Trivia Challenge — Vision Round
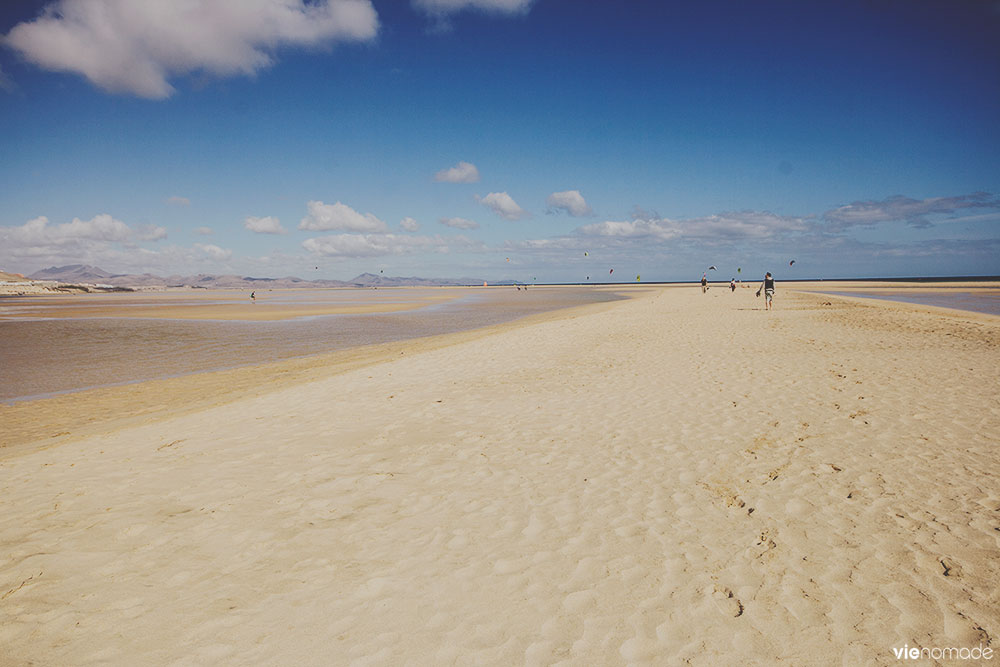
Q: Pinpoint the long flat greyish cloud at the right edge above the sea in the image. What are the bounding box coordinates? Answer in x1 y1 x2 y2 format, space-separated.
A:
823 192 1000 231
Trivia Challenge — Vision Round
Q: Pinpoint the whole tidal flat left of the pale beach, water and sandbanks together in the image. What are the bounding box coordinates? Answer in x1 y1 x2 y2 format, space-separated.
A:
0 287 617 402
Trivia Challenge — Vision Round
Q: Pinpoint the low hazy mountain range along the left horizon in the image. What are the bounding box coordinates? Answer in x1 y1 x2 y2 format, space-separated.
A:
29 264 483 290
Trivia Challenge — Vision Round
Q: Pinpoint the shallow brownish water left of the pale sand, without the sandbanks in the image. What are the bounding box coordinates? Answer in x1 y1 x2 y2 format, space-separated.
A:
0 287 619 402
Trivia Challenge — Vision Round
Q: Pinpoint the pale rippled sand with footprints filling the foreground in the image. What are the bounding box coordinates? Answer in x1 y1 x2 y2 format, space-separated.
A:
0 283 1000 666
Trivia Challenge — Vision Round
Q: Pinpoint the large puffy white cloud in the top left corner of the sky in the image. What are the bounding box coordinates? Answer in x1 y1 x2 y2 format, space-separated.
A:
4 0 378 99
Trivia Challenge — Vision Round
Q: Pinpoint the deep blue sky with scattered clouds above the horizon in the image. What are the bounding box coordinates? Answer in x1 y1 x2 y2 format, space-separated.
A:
0 0 1000 282
